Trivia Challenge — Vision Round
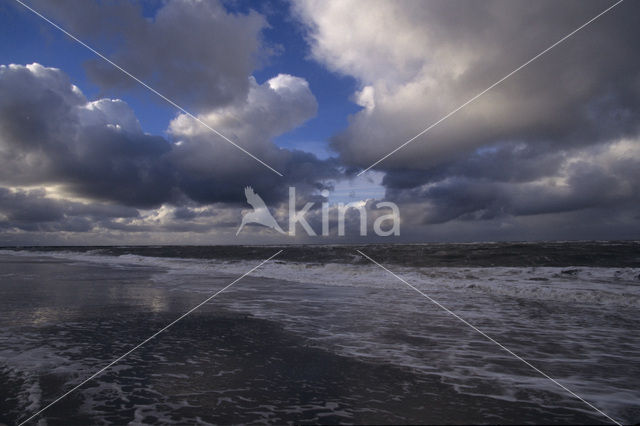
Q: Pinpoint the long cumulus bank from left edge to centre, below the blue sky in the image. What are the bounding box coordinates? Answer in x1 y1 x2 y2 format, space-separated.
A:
0 64 339 215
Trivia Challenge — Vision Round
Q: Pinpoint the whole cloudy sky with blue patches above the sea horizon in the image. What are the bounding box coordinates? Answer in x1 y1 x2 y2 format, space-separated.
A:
0 0 640 245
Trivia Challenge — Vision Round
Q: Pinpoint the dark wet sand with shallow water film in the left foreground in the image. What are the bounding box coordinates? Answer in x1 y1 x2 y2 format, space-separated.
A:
0 251 637 425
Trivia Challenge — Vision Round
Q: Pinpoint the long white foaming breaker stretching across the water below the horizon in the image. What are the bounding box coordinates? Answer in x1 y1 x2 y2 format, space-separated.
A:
0 250 640 308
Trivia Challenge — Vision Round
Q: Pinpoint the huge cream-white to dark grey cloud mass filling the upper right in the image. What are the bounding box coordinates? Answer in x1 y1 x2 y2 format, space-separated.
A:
293 0 640 238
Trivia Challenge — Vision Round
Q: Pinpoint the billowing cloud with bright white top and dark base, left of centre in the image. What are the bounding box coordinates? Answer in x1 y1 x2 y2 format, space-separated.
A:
169 74 340 203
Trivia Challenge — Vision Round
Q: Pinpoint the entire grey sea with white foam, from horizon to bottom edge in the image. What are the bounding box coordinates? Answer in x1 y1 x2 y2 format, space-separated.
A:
0 241 640 425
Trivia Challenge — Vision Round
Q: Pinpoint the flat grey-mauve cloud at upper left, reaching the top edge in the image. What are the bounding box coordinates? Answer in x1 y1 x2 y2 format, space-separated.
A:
26 0 269 109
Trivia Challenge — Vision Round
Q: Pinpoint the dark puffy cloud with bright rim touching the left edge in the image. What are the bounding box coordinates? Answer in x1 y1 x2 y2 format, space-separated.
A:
0 64 173 207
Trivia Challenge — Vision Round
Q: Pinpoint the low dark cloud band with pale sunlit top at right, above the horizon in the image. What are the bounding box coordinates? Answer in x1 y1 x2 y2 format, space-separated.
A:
386 141 640 223
